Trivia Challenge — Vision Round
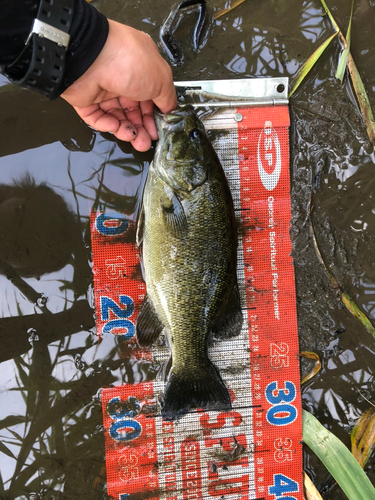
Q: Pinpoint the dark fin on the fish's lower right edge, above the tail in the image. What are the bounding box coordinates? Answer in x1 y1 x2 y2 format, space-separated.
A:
211 283 243 340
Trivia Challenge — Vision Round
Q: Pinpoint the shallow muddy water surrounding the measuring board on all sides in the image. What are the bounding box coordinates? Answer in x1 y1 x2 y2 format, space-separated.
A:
0 0 375 500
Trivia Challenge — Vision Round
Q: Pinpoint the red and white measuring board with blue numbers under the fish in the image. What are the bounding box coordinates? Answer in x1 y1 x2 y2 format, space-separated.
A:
92 79 303 500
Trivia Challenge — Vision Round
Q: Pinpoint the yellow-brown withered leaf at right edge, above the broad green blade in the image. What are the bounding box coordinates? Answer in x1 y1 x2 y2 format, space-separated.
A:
350 407 375 468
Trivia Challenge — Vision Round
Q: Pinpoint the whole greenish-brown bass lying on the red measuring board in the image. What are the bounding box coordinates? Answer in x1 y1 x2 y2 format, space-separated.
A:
136 107 242 420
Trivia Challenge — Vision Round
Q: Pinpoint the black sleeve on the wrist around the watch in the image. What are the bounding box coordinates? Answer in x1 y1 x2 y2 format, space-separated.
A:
0 0 108 99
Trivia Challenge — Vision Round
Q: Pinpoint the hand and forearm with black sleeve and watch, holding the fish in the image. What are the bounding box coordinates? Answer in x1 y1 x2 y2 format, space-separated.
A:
0 0 177 151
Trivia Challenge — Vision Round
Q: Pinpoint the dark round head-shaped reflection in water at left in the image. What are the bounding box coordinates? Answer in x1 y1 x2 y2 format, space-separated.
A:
0 176 87 282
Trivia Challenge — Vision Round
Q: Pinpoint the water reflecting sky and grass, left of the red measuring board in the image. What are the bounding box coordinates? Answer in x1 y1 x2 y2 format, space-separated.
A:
0 89 152 500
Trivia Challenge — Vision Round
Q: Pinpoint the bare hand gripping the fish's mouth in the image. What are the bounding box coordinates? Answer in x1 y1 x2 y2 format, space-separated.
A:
61 20 177 151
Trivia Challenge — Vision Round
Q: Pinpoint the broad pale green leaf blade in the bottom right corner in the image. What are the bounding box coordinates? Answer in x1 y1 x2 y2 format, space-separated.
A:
302 410 375 500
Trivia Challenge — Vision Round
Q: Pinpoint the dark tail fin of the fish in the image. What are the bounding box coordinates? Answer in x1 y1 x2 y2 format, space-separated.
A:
161 361 232 420
